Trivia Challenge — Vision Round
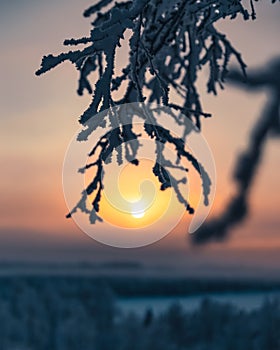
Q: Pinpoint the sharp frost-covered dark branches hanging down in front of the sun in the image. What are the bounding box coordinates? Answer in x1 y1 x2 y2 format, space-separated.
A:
36 0 276 227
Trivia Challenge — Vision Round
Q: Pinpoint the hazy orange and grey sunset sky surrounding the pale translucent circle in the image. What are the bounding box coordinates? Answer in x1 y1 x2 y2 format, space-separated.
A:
0 0 280 276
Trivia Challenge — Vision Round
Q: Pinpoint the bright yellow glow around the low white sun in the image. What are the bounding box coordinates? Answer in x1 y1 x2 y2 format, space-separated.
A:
90 159 174 228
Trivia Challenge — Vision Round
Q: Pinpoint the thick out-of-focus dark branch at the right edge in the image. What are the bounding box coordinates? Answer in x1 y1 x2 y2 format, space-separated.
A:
192 58 280 243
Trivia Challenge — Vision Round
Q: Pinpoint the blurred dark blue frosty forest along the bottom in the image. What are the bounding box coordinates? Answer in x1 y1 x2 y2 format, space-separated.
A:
0 277 280 350
